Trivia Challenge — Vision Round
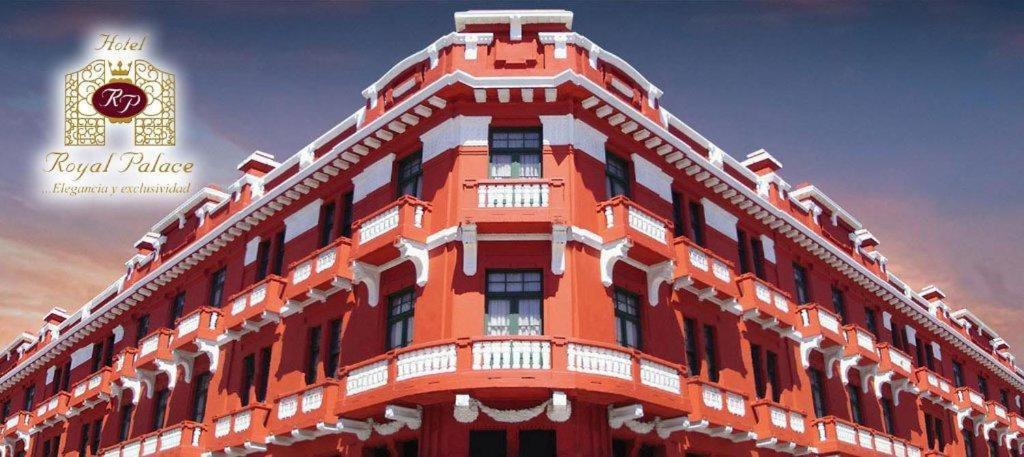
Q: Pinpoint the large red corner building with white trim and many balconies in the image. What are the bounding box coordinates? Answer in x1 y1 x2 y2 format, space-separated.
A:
0 10 1024 457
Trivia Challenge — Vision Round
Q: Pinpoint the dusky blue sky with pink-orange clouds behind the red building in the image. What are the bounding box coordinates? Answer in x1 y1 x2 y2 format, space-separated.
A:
0 0 1024 354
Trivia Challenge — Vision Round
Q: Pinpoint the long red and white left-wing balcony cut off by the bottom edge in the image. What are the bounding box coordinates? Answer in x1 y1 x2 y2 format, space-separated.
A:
99 422 205 457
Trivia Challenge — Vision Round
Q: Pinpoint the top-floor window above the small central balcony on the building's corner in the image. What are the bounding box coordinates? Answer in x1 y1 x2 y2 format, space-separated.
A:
490 128 542 178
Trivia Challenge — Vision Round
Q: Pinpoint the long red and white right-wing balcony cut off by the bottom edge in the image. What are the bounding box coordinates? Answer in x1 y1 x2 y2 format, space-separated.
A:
812 416 922 457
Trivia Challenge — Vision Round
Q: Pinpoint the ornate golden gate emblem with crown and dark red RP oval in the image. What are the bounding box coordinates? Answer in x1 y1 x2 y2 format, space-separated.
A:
63 59 175 147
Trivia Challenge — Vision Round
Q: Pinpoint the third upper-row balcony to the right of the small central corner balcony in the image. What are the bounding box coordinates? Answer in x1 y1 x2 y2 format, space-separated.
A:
736 273 800 335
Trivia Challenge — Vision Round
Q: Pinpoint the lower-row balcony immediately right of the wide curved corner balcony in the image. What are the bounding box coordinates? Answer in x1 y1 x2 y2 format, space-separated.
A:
686 377 756 442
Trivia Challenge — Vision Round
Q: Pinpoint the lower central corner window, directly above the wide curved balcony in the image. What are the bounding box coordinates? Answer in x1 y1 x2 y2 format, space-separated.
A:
484 271 544 335
